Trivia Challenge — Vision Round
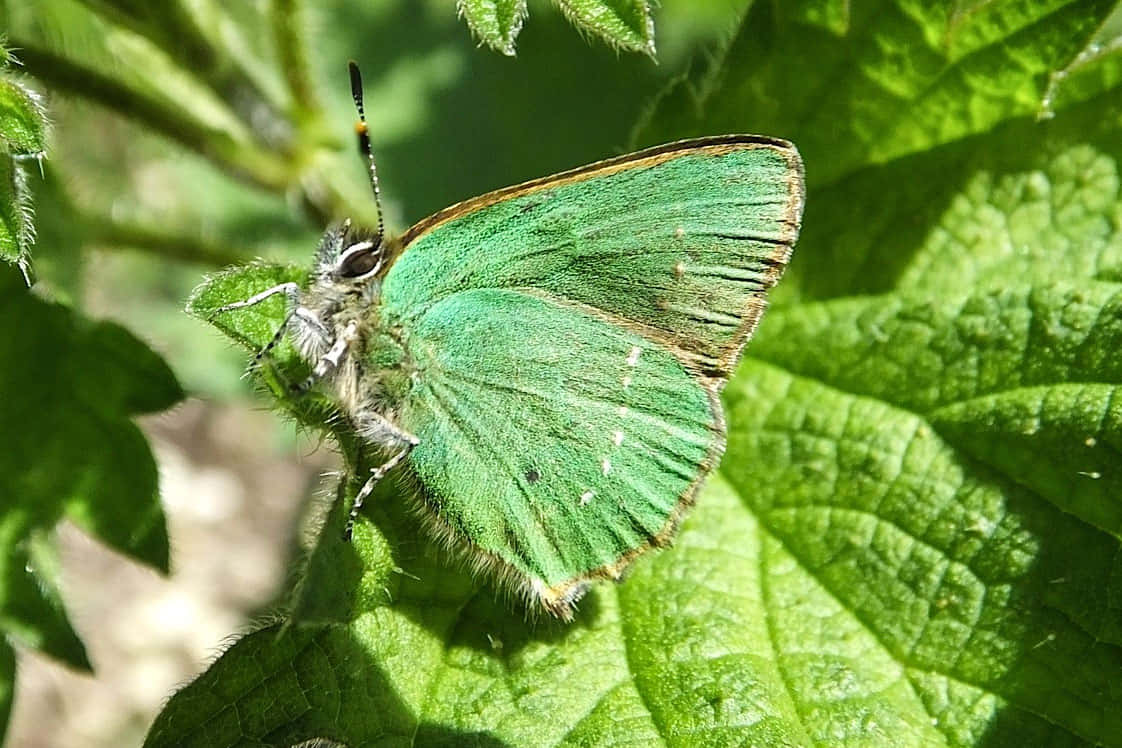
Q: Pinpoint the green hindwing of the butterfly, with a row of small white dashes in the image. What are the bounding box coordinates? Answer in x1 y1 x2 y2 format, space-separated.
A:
401 289 723 615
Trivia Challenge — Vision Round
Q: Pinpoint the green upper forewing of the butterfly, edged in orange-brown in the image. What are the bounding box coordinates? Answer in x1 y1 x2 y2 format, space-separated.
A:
383 136 803 378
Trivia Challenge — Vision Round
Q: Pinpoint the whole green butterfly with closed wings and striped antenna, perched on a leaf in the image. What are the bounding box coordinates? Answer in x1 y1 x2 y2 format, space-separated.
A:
212 64 804 619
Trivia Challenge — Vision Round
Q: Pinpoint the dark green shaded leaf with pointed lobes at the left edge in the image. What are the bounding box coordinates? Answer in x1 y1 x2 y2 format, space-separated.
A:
0 269 182 667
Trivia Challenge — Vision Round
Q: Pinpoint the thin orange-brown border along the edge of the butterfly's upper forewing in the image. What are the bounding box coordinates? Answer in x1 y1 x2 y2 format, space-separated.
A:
383 135 806 384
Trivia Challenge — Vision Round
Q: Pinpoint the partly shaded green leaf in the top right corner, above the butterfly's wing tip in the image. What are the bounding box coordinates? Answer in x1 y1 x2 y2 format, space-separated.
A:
637 0 1118 187
